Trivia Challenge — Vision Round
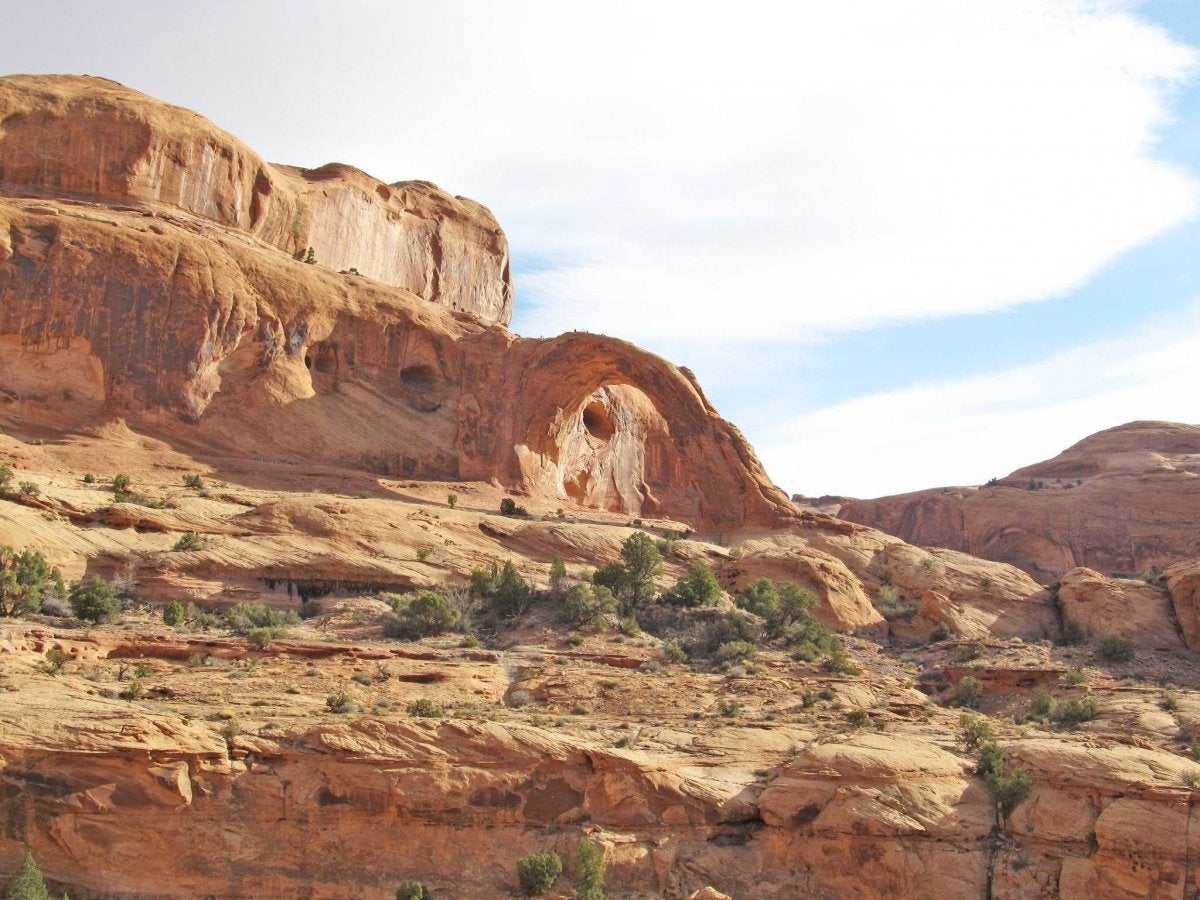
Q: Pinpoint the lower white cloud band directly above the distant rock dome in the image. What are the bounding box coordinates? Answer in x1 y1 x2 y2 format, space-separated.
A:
757 306 1200 497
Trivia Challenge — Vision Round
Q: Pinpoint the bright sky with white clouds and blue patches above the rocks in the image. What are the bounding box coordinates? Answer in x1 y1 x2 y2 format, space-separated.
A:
0 0 1200 497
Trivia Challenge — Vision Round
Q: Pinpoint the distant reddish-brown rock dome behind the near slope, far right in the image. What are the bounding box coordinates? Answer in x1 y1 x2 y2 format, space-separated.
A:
838 421 1200 582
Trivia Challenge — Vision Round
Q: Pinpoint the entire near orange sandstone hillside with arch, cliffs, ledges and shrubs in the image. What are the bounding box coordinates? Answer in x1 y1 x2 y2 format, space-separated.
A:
0 77 1200 900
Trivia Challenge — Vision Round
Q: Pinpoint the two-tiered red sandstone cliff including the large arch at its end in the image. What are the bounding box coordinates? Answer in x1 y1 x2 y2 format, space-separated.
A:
0 77 793 528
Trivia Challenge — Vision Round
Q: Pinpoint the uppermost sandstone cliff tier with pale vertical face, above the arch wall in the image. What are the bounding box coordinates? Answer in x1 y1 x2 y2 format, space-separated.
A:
0 76 512 324
